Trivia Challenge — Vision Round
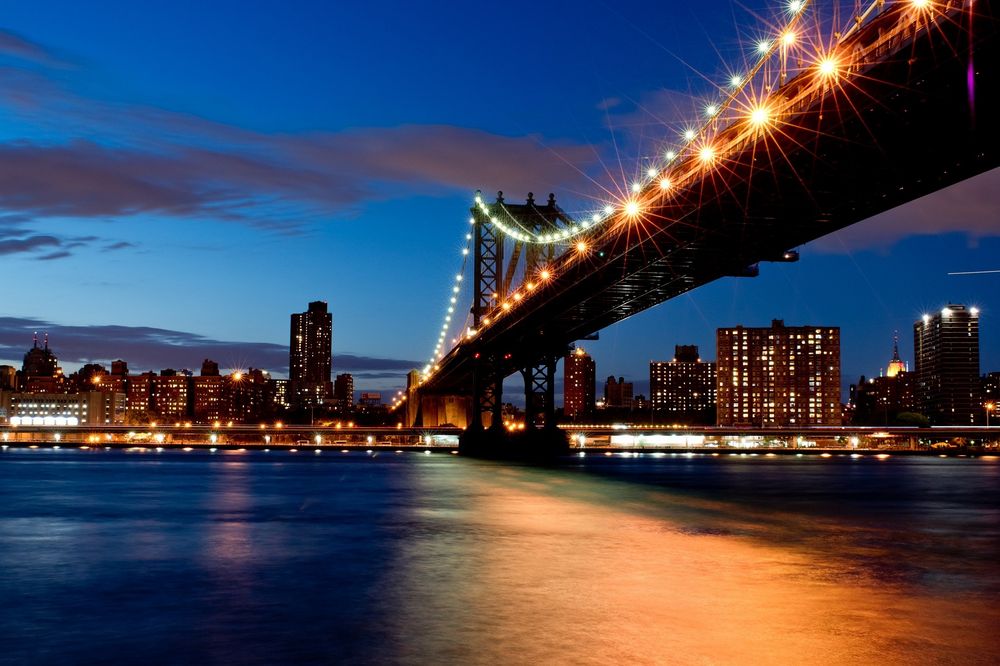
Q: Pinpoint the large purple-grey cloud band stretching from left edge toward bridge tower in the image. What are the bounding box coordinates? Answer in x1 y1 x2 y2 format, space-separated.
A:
0 36 594 231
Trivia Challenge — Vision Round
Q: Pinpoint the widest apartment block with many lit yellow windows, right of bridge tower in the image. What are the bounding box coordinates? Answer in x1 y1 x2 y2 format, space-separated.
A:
716 319 841 427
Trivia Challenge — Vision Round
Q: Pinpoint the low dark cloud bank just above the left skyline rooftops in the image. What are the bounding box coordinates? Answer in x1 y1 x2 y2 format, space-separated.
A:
0 317 418 379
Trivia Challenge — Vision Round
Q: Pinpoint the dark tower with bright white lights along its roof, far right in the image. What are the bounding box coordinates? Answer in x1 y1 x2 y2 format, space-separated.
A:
913 305 983 425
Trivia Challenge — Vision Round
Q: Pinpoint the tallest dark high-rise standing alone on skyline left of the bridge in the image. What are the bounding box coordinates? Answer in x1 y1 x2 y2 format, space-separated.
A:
288 301 333 407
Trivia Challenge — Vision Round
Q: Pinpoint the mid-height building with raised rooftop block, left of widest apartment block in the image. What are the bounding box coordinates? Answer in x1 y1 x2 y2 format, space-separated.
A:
649 345 716 424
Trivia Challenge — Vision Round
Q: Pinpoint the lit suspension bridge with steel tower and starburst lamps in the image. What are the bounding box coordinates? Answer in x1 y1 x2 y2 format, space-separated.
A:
397 0 1000 449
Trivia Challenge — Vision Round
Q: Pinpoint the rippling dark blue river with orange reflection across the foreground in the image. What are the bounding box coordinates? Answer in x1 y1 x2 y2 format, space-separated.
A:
0 449 1000 664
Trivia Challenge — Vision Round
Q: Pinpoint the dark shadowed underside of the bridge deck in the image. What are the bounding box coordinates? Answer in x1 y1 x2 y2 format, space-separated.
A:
425 0 1000 436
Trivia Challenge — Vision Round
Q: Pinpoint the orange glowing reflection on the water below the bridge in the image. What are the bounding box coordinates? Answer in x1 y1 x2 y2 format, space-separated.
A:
384 461 1000 664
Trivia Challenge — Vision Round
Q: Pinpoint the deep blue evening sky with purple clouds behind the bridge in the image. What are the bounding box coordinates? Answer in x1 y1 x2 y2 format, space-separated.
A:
0 0 1000 392
